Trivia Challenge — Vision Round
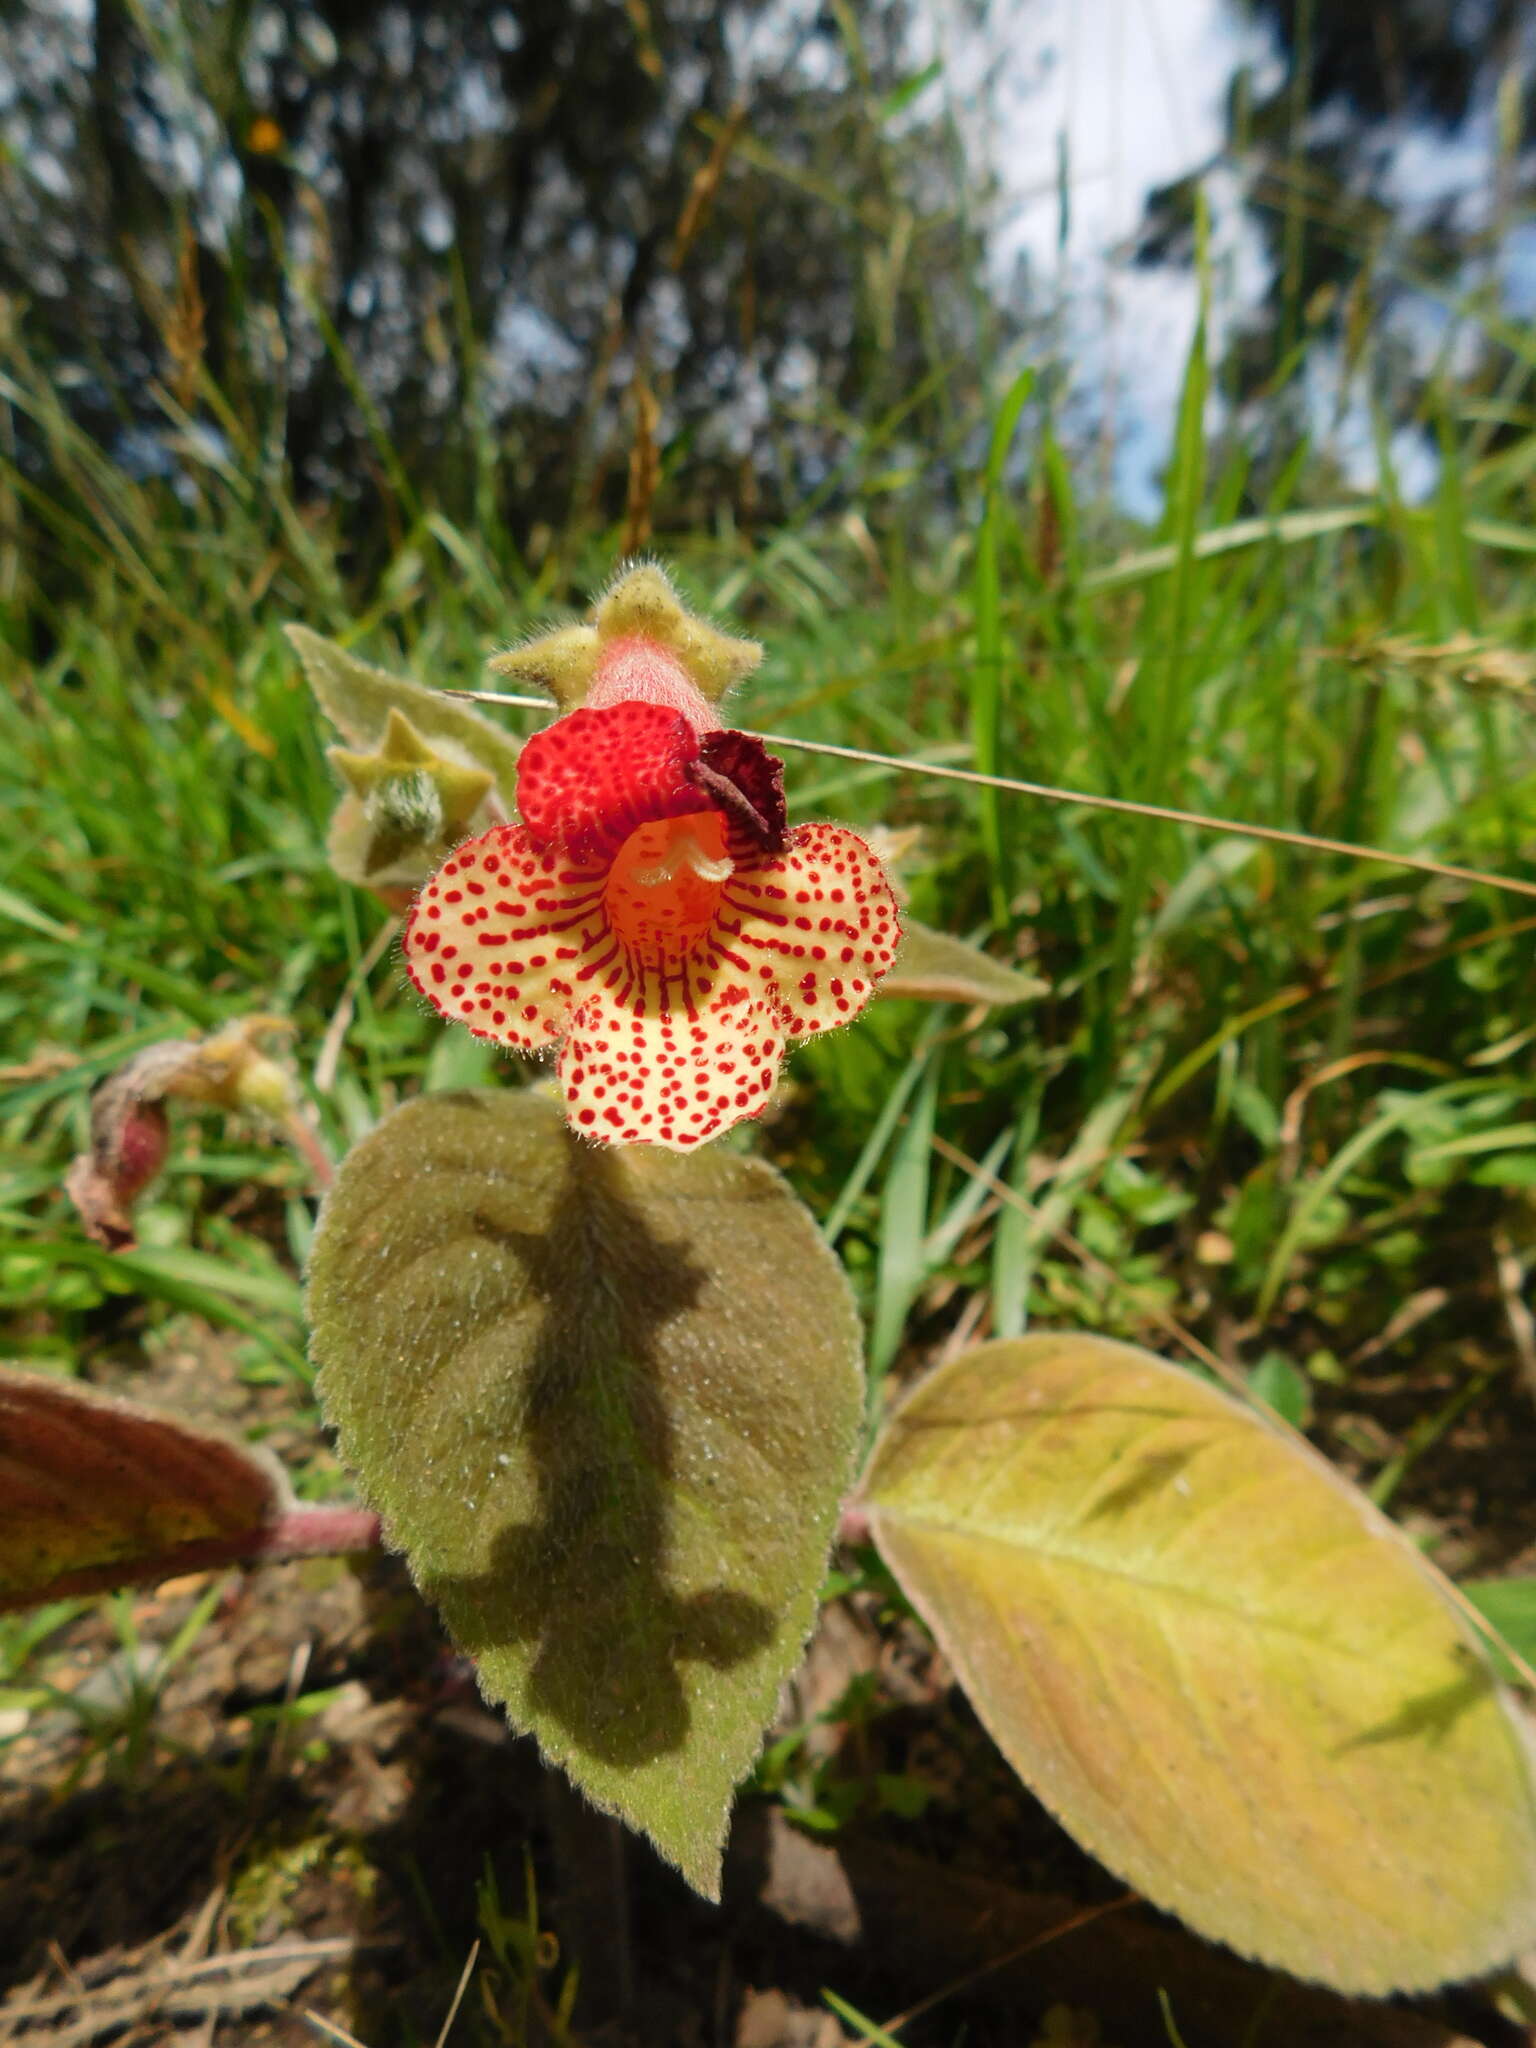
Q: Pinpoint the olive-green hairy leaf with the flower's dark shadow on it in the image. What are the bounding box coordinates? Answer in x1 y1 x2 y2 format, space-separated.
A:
309 1090 862 1896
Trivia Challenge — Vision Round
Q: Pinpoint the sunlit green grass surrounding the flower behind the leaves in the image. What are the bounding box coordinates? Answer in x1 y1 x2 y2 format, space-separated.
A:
0 288 1536 1531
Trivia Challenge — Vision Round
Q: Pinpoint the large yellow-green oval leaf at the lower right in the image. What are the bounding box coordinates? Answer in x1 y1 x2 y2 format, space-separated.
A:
866 1335 1536 1995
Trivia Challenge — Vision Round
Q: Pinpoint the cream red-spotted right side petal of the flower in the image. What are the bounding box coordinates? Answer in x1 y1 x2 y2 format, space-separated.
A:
717 825 901 1038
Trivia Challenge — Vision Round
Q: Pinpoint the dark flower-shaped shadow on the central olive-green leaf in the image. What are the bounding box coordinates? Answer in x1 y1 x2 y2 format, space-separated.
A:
422 1141 776 1765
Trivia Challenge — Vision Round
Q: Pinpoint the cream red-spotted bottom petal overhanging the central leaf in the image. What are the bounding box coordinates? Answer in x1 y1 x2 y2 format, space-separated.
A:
559 975 784 1151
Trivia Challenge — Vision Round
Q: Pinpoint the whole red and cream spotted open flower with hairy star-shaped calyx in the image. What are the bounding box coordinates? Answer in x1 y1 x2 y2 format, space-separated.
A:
406 569 901 1151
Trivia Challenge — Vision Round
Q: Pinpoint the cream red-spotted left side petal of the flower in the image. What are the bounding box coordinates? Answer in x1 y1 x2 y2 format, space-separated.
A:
401 825 616 1053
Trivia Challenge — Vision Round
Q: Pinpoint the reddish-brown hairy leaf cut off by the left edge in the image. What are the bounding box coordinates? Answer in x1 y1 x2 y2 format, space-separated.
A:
0 1366 291 1612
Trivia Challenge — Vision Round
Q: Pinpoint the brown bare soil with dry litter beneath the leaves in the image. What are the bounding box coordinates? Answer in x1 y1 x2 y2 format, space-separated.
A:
0 1321 1536 2048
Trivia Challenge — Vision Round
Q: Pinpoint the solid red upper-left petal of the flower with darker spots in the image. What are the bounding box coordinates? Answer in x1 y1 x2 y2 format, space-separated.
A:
518 700 709 860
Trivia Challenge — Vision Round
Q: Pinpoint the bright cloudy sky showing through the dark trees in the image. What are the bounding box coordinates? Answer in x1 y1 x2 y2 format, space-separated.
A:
962 0 1536 518
